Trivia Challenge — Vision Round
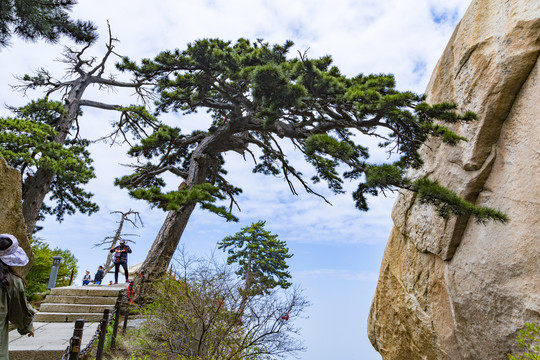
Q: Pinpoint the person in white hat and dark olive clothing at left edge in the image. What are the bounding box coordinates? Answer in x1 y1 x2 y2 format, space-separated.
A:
0 234 34 359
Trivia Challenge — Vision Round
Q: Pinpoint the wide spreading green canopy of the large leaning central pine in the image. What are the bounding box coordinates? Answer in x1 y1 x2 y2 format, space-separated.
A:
117 39 504 222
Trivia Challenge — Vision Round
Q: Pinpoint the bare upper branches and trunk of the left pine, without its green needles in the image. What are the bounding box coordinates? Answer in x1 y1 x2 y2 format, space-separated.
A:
15 29 157 233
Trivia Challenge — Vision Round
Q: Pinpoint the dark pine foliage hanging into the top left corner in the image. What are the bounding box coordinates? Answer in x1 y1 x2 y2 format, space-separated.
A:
0 0 97 47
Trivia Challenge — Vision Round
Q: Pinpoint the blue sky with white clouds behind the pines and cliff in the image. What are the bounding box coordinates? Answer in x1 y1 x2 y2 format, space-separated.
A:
0 0 469 360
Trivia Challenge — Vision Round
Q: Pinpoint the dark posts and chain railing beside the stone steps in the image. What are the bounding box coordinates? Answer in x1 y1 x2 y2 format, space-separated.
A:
61 290 131 360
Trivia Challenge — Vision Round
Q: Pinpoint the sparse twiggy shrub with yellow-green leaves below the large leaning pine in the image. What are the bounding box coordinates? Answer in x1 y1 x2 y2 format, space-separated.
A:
131 250 308 360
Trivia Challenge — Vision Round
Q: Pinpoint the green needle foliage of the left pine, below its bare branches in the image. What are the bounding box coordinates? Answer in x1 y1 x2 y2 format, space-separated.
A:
0 99 99 221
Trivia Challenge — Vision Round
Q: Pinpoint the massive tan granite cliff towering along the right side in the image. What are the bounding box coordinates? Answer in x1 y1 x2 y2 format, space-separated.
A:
368 0 540 360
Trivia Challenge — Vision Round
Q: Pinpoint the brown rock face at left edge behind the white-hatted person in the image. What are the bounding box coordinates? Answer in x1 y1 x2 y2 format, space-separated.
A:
0 157 34 275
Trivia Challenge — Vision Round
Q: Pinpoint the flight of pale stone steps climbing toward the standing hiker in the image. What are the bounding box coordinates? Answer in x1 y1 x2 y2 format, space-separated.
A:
34 284 128 322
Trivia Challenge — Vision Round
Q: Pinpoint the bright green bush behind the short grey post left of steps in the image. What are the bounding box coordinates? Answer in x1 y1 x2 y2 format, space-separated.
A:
26 239 77 297
